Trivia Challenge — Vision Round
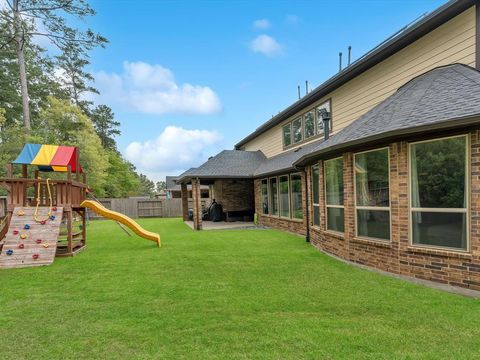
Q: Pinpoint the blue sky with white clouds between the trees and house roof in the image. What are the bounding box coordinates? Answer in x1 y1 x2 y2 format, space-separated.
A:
82 0 445 180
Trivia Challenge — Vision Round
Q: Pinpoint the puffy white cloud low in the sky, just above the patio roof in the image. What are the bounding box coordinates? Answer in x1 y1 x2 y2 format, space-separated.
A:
124 126 223 181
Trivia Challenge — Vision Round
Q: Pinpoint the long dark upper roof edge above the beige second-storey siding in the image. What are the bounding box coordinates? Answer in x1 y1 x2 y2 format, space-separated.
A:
235 0 478 149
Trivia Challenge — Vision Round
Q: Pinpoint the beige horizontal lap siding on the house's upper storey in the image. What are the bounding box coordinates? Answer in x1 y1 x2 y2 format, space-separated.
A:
244 7 475 157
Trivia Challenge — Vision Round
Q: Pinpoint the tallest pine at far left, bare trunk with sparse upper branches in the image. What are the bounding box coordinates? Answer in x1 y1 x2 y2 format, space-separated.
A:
0 0 107 129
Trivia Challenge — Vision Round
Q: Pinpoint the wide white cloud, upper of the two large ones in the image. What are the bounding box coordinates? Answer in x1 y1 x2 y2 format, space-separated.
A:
95 61 222 115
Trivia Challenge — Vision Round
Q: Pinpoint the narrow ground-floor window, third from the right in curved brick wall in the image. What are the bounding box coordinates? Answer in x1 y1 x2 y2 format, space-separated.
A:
324 157 345 232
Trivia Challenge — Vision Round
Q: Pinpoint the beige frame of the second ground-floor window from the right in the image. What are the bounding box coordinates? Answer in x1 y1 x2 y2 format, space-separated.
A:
352 146 392 244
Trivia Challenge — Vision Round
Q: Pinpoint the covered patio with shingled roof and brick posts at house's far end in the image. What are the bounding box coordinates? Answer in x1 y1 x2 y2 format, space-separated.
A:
177 150 265 230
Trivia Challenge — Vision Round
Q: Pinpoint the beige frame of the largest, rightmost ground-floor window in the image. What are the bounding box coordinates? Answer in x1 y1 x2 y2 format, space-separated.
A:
407 133 472 253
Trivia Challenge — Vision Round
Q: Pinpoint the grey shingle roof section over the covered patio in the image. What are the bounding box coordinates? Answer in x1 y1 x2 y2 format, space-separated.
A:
178 150 265 181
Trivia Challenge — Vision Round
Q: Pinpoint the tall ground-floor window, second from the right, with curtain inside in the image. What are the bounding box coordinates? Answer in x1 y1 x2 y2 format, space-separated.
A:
355 148 390 240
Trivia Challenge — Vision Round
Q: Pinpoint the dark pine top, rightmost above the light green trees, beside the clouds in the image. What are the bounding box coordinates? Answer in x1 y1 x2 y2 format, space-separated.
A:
91 105 120 150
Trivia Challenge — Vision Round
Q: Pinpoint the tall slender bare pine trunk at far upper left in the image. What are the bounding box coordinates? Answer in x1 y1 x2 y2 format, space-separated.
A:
13 0 31 130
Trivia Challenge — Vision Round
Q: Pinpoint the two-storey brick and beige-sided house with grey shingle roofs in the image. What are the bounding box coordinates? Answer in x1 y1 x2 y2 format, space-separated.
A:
177 0 480 290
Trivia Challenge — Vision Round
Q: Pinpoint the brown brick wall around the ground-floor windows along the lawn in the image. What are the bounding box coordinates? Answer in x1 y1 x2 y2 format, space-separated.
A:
255 130 480 290
